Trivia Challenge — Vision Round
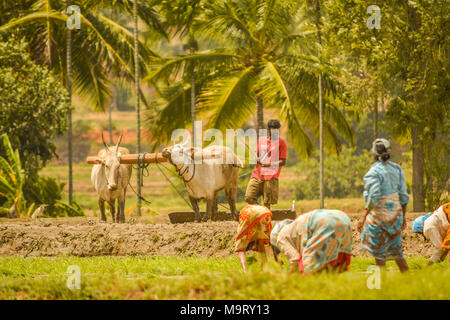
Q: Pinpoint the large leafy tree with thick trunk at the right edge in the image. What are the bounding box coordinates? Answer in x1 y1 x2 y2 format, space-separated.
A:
327 0 449 212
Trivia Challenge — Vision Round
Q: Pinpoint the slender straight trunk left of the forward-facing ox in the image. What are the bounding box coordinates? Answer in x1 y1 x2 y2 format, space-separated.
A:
66 6 73 205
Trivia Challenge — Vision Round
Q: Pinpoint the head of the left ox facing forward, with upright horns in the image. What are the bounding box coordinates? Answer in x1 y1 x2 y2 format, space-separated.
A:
97 132 122 191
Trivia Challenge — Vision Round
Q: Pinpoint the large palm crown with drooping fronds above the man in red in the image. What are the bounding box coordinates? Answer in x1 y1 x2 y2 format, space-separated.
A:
146 0 353 156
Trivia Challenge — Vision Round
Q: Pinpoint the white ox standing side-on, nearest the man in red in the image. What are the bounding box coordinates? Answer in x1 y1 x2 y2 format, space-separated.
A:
163 144 243 222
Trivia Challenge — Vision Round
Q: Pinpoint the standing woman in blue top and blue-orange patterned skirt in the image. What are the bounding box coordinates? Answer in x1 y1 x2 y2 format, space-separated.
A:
358 139 409 272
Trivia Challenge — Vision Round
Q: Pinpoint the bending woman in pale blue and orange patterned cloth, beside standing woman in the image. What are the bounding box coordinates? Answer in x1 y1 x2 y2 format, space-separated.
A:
270 209 352 275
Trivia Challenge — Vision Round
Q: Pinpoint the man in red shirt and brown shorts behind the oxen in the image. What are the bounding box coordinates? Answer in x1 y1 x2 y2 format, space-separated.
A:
245 120 287 209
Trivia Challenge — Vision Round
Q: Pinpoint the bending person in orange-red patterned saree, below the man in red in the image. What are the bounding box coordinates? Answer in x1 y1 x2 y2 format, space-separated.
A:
235 204 272 271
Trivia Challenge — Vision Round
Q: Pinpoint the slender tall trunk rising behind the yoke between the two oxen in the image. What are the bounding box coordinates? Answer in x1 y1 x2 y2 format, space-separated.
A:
133 0 141 216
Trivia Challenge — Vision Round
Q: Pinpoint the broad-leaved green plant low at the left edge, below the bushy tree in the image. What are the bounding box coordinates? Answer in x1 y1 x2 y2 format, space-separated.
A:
0 134 26 218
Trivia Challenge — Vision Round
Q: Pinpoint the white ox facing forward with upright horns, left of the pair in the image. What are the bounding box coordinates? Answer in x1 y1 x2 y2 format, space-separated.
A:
91 132 133 222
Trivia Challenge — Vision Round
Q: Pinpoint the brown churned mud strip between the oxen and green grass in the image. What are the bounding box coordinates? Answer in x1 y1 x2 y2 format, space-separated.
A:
0 214 431 257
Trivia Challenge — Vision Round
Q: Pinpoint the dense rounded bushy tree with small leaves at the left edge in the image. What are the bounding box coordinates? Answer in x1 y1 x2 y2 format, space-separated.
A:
0 40 70 180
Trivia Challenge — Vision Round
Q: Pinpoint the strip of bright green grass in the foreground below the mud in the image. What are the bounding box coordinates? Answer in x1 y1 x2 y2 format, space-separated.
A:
0 257 450 299
